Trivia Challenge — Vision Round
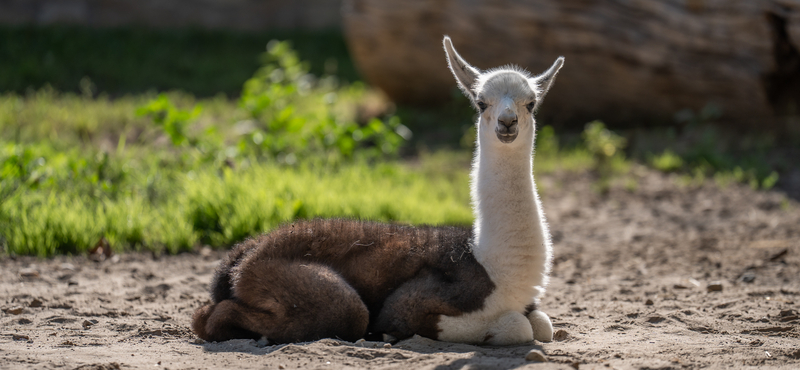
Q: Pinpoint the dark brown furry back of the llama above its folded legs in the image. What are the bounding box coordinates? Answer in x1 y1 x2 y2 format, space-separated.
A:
212 219 484 311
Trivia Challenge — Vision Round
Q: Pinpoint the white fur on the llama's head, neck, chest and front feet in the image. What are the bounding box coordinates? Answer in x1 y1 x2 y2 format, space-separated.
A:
439 36 564 345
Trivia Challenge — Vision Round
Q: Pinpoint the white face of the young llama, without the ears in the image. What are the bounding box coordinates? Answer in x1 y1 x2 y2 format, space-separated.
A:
474 70 536 144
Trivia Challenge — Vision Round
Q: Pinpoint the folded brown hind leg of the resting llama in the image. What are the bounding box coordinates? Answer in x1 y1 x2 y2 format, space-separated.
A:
193 260 369 343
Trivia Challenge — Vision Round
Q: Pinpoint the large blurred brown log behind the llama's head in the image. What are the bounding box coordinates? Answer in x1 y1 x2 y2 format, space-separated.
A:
342 0 800 129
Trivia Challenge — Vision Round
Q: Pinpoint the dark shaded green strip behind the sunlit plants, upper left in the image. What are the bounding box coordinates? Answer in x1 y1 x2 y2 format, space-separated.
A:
0 26 359 97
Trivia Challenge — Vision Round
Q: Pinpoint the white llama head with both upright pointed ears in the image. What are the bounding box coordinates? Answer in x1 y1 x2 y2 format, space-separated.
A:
443 36 564 145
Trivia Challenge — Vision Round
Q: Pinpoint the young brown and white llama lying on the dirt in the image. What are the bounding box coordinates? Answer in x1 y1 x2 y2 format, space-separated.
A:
192 36 564 345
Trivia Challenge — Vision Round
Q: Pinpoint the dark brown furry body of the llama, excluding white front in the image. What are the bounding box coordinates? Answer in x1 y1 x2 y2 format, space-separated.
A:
192 220 494 343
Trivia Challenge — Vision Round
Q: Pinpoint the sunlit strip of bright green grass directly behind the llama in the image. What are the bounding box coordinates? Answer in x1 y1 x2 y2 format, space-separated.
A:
0 146 472 256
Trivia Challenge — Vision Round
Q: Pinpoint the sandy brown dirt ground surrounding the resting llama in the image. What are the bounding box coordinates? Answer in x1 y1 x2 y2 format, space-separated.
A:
0 168 800 369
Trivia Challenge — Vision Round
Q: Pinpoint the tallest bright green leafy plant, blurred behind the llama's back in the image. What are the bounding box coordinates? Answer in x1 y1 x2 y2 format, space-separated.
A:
234 41 408 164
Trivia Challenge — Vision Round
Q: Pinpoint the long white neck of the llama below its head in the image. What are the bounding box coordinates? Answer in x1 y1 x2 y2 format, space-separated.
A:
472 138 549 286
